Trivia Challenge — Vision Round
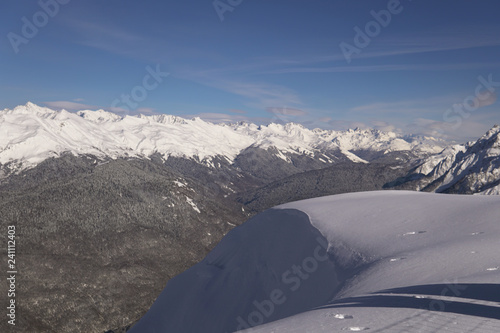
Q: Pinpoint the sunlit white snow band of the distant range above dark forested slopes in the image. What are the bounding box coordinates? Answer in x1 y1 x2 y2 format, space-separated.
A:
0 103 443 169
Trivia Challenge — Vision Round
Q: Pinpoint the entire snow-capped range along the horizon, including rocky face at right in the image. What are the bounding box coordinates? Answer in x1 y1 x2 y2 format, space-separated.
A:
0 103 500 194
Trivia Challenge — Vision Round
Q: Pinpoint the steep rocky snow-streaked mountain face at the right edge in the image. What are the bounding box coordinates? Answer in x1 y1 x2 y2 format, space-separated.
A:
388 125 500 194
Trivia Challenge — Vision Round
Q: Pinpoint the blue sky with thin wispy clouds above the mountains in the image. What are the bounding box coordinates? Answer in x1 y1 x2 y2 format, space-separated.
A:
0 0 500 141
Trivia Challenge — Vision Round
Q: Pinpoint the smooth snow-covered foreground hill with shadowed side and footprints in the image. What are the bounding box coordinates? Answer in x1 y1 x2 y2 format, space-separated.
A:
131 191 500 333
